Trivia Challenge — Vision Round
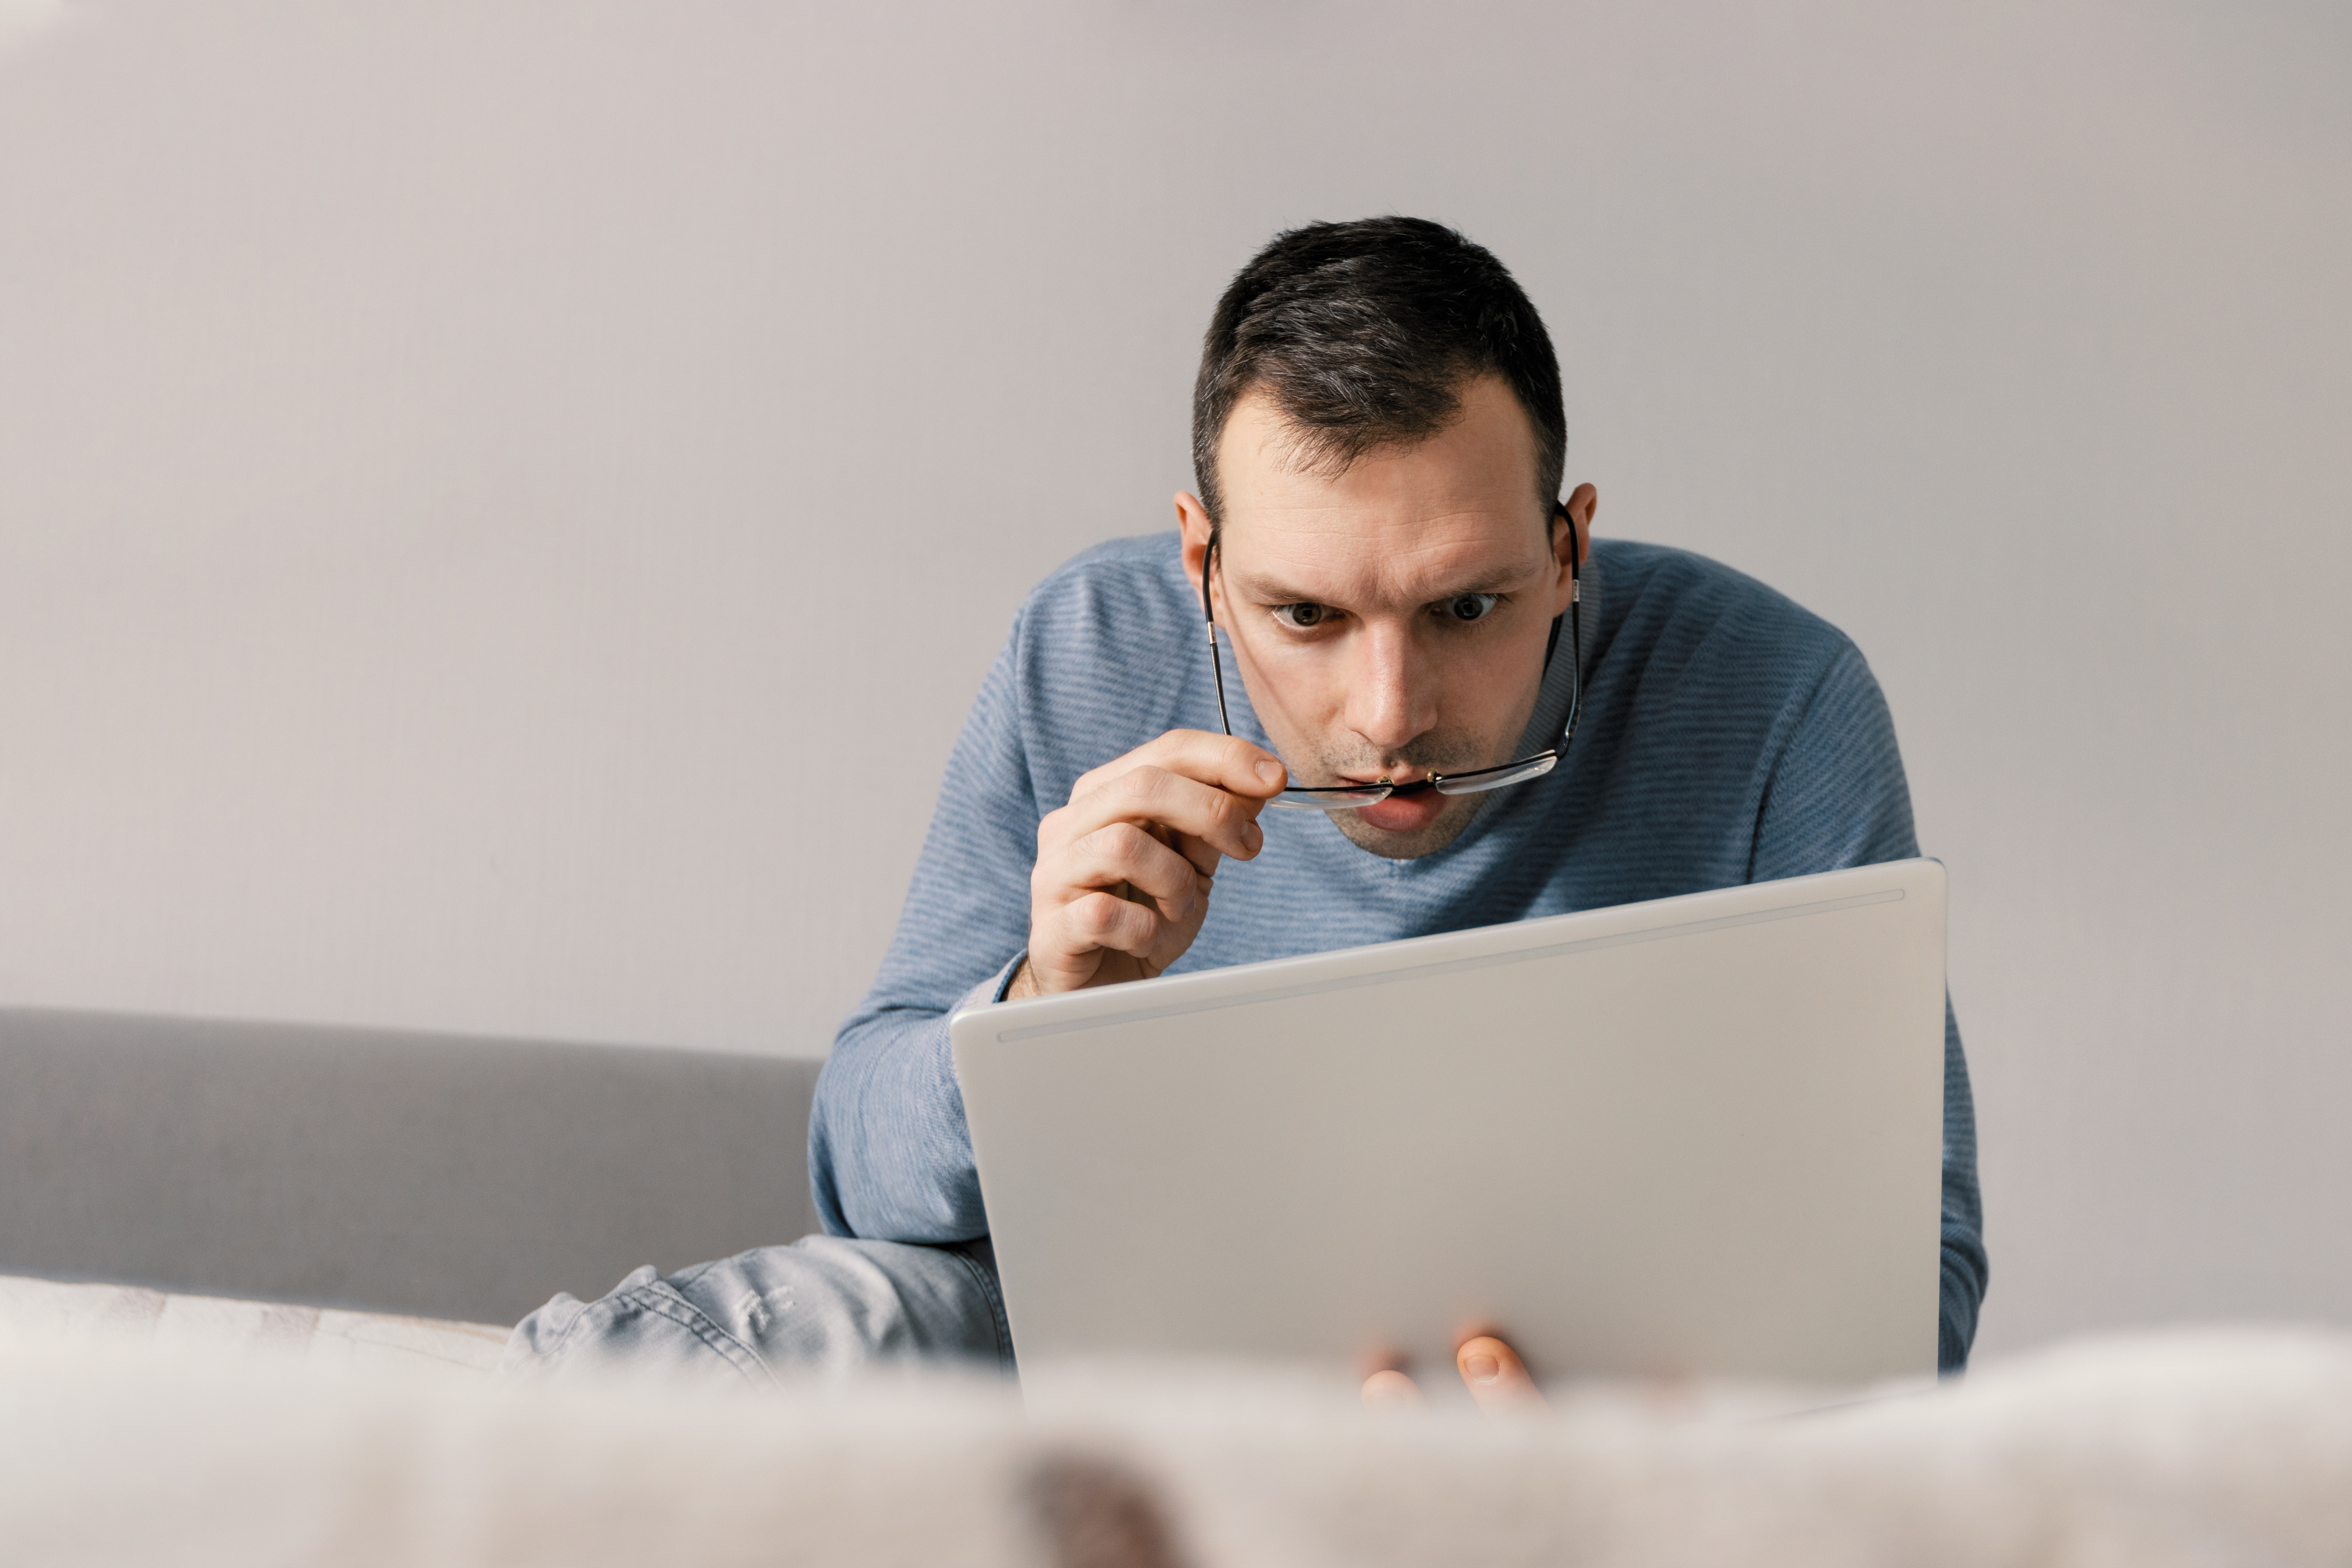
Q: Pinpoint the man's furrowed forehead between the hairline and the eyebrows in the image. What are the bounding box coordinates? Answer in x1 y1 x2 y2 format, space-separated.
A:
1218 378 1550 604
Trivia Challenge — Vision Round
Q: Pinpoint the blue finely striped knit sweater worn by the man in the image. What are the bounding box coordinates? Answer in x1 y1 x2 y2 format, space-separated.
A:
809 534 1985 1370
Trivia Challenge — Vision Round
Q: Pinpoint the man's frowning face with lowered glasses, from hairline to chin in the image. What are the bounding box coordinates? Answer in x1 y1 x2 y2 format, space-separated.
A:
1179 376 1590 860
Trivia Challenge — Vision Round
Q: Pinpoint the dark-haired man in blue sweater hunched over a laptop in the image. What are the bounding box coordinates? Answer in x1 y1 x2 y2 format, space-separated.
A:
511 218 1985 1401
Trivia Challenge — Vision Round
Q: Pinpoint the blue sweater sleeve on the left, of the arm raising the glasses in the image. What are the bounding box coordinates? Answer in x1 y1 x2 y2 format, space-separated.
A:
809 611 1040 1243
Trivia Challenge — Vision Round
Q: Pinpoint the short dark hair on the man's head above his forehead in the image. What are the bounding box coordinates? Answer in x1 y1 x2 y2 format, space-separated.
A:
1193 218 1569 524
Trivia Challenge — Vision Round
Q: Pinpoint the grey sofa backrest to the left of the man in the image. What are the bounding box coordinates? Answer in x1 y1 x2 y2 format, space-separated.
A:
0 1009 821 1323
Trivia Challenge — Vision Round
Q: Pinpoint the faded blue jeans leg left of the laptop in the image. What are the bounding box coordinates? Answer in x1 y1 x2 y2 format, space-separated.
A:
499 1237 1014 1387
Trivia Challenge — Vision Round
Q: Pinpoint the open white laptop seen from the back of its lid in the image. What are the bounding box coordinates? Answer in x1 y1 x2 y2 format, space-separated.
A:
950 860 1945 1382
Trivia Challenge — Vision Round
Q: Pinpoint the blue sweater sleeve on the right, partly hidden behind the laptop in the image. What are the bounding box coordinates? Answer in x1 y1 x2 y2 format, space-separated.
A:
1750 644 1988 1373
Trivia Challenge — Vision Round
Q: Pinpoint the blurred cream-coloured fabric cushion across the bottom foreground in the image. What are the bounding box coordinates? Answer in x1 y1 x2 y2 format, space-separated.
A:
0 1293 2352 1568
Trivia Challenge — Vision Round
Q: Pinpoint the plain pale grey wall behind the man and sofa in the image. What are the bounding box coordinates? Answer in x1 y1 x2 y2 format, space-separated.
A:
0 0 2352 1350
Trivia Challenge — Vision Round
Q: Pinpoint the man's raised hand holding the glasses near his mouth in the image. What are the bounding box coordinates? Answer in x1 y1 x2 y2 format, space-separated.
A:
1007 729 1284 997
